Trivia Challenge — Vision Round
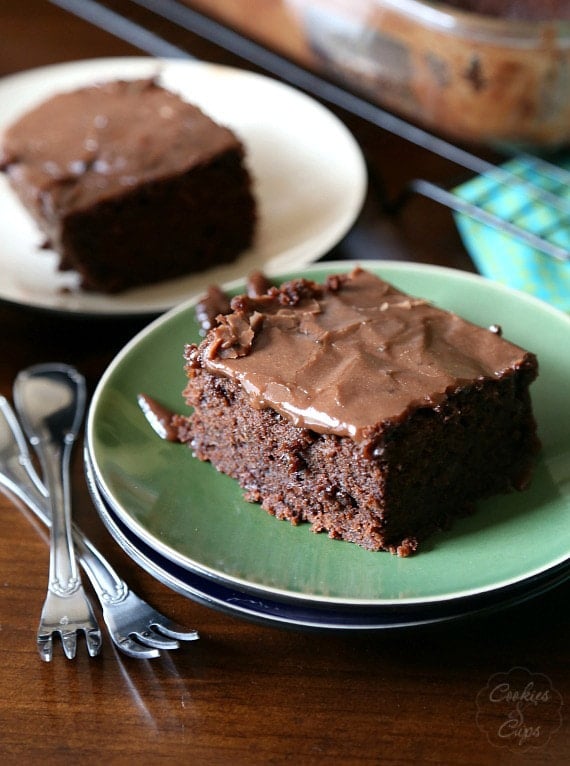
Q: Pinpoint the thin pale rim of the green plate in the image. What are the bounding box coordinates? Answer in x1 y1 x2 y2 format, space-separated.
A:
86 260 570 607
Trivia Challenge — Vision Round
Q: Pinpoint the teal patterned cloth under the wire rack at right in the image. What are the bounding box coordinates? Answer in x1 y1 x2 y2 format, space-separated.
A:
454 156 570 312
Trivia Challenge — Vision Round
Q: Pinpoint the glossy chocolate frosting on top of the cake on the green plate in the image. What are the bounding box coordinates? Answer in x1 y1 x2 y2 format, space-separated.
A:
187 269 528 440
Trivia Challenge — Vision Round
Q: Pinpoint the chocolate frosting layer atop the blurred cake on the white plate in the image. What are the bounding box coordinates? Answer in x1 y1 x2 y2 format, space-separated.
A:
0 79 239 221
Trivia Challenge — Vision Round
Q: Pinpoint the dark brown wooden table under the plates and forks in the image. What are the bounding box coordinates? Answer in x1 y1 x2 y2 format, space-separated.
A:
0 0 570 764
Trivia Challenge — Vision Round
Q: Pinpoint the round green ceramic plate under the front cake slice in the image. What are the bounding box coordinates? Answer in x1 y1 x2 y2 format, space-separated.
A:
87 262 570 608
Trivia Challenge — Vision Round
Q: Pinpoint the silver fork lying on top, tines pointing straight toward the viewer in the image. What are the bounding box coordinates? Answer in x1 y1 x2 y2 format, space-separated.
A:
14 364 101 662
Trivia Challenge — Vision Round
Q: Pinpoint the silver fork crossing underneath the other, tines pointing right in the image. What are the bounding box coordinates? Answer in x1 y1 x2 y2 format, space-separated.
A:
0 396 199 659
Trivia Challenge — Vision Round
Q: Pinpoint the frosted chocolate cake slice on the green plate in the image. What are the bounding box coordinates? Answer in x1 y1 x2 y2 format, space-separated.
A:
175 269 538 556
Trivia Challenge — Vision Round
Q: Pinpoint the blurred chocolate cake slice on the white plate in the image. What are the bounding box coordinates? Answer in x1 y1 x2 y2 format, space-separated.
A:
0 79 256 293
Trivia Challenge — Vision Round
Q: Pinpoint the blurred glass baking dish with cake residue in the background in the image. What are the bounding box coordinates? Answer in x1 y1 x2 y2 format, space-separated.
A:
287 0 570 147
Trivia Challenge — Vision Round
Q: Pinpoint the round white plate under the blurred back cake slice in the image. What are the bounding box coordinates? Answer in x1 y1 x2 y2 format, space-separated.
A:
0 58 366 315
